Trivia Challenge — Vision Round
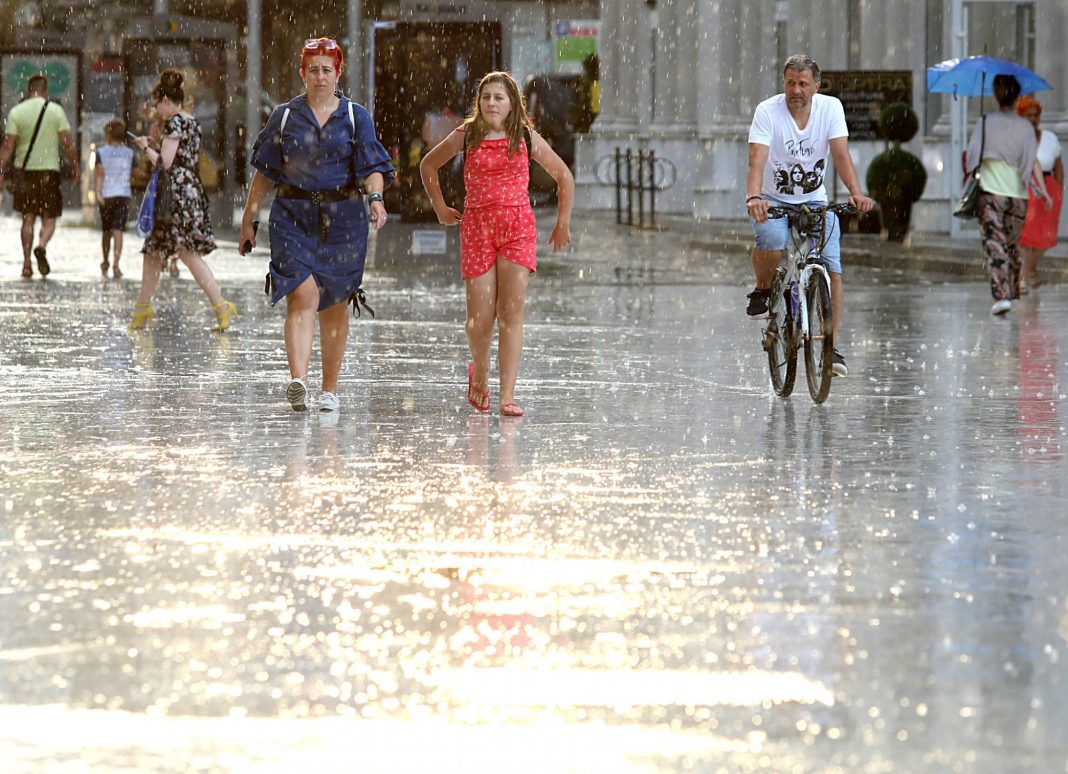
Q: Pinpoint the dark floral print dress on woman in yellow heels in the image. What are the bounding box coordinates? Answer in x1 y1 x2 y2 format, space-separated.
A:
142 113 215 257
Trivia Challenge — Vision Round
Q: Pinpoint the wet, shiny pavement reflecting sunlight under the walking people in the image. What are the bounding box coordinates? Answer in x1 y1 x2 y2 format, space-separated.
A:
0 216 1068 772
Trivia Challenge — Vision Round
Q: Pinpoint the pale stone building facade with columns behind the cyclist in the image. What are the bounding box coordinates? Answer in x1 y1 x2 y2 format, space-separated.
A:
576 0 1068 234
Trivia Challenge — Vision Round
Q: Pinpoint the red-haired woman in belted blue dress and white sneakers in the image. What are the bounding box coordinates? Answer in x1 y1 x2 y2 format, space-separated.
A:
238 37 393 411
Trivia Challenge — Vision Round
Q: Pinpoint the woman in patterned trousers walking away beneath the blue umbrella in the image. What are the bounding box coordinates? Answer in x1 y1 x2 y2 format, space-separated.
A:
967 75 1038 316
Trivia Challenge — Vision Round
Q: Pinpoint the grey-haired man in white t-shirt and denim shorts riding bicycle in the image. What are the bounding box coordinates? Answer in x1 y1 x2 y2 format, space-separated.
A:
745 54 875 376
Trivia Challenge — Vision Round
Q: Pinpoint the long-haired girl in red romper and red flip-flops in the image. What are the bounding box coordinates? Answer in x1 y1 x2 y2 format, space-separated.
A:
420 73 575 416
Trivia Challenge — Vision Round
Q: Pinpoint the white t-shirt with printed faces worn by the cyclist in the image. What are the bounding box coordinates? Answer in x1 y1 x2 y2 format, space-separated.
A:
749 94 849 204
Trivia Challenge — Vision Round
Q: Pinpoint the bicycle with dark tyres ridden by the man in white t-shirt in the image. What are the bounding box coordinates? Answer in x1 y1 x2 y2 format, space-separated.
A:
764 203 857 404
